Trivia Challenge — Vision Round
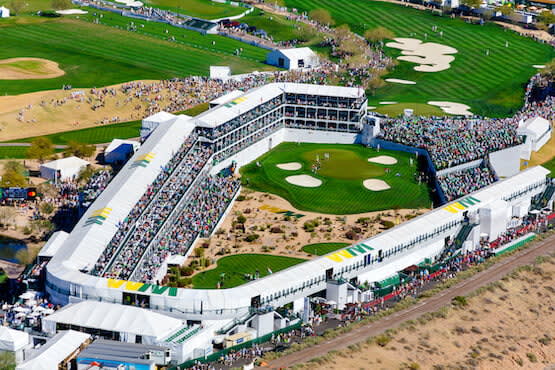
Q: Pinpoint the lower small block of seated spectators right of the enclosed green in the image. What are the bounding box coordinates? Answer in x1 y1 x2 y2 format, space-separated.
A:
437 166 496 202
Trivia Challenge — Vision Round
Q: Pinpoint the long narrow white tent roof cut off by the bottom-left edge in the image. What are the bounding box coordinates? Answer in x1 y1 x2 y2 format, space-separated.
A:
16 330 91 370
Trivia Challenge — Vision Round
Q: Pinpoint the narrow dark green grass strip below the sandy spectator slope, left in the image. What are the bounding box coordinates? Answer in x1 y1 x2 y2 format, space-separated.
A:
4 121 141 148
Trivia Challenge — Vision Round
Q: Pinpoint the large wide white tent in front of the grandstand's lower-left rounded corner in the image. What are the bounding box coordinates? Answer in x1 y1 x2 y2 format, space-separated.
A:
42 301 185 344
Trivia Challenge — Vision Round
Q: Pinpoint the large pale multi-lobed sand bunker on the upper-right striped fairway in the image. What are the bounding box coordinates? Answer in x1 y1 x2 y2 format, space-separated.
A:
385 38 457 72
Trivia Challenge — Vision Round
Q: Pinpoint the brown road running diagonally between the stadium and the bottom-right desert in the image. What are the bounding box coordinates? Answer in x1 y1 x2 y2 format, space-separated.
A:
269 235 555 369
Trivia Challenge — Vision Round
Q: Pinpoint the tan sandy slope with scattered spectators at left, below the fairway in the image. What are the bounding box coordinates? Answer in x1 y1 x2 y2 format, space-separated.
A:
0 81 161 141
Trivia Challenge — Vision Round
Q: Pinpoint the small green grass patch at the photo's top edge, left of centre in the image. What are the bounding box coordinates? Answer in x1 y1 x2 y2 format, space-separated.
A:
145 0 243 19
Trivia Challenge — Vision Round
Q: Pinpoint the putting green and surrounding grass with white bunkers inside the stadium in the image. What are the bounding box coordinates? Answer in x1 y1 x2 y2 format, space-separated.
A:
240 143 432 214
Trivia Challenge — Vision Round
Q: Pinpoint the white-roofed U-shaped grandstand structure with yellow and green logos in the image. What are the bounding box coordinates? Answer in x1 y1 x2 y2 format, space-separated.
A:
46 83 553 360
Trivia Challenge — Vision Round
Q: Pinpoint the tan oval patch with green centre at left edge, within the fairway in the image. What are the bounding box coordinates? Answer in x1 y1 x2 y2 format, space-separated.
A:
0 58 65 80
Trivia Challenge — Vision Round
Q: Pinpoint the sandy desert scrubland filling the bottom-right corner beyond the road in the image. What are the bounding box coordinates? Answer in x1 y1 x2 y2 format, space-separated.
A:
307 258 555 370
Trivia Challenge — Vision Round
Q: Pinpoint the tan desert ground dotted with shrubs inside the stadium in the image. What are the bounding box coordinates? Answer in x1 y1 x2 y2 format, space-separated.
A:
189 190 428 268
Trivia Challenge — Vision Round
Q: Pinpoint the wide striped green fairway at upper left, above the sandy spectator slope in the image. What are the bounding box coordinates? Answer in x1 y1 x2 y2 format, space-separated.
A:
0 14 270 95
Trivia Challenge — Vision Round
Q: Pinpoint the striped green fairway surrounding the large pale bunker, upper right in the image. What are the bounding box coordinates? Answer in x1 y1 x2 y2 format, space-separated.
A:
285 0 555 117
